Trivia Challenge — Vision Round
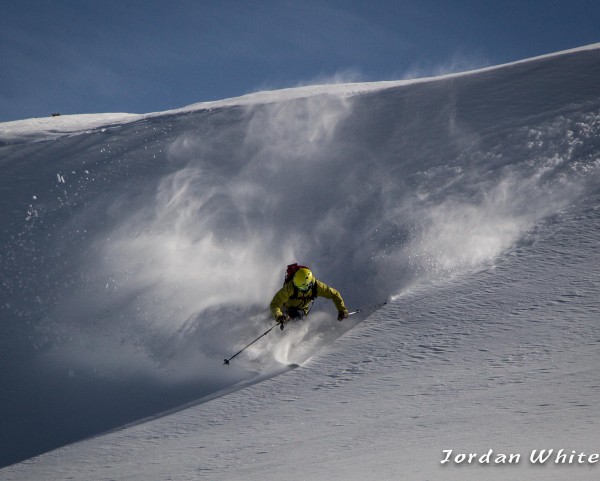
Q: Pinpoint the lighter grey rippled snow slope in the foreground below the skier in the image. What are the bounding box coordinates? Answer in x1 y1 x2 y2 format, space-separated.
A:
5 194 600 481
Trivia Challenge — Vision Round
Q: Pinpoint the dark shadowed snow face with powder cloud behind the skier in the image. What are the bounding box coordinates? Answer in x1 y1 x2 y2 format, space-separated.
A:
0 49 600 464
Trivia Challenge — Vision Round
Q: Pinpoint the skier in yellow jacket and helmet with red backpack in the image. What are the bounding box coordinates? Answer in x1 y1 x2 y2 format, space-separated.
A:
270 264 348 330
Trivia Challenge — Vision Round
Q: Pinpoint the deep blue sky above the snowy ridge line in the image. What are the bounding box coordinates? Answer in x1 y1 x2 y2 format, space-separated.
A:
0 0 600 121
